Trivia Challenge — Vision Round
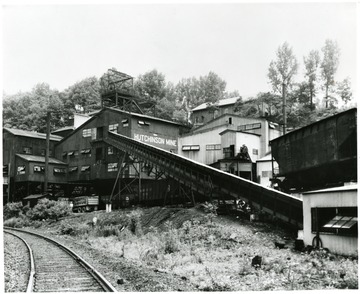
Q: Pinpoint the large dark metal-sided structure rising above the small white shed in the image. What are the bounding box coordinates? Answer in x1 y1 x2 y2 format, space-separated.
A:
272 111 356 175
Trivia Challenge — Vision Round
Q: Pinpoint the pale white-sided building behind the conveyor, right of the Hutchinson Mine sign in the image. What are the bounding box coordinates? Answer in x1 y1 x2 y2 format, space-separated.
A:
178 114 281 185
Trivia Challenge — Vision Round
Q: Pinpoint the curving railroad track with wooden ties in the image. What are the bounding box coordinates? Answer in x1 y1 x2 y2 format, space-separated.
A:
4 227 117 292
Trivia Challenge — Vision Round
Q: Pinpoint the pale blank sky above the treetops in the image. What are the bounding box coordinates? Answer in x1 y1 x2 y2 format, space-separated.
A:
1 1 358 96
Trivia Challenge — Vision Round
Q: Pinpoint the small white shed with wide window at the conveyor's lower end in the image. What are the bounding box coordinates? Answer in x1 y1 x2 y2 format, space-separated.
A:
303 185 358 256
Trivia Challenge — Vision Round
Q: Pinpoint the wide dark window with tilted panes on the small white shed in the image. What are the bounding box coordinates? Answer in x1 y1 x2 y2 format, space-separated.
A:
311 207 358 236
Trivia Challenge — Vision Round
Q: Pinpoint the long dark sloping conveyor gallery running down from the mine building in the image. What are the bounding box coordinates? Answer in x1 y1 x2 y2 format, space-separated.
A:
104 132 303 228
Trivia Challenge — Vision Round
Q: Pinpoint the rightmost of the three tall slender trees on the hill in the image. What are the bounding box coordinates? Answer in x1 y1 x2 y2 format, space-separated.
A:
320 39 340 108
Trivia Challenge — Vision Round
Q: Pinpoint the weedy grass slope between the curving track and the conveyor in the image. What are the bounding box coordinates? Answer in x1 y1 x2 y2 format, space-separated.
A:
5 208 358 291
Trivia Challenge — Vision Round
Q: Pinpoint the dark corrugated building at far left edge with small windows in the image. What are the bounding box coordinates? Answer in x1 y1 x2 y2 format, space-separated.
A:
3 128 64 203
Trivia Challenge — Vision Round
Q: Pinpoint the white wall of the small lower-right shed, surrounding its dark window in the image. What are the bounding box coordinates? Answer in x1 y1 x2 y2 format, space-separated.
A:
303 186 358 255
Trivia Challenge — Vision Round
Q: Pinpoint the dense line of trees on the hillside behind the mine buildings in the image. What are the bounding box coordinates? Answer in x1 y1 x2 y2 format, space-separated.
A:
3 40 355 132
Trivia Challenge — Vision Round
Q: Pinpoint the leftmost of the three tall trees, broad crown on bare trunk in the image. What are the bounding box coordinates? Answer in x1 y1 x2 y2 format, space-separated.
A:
268 42 298 134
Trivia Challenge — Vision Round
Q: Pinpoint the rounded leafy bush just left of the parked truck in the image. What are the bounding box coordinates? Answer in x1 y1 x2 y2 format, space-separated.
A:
26 199 71 220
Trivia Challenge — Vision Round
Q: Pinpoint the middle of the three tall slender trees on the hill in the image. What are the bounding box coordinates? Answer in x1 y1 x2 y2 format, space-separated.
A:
304 50 320 109
